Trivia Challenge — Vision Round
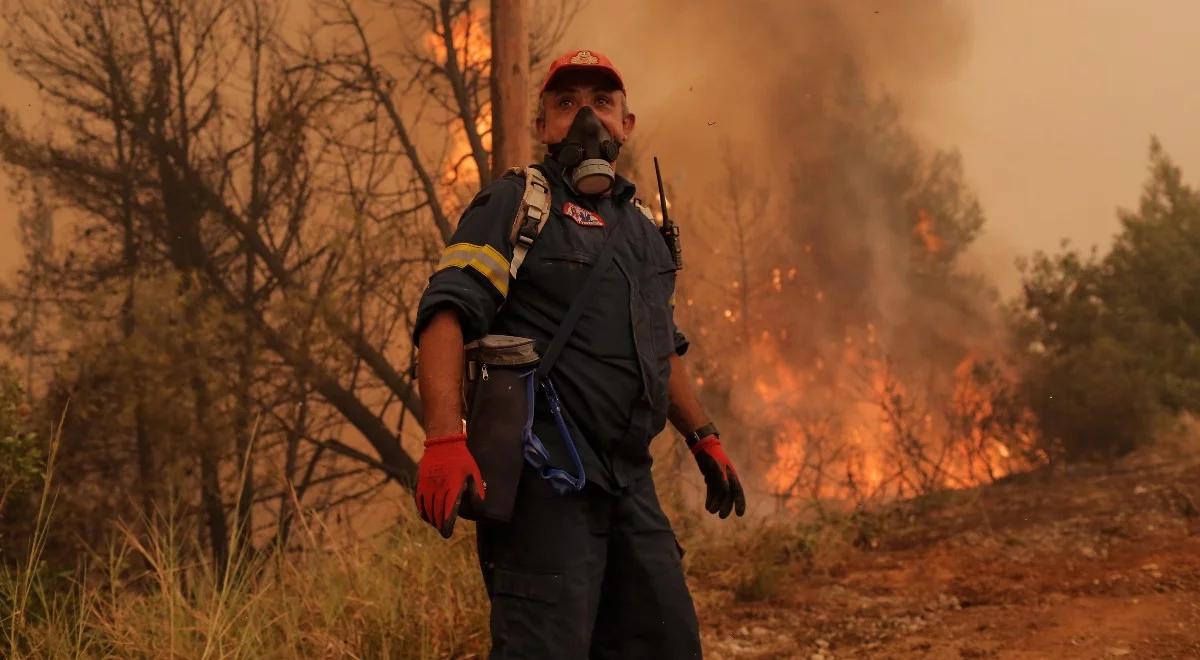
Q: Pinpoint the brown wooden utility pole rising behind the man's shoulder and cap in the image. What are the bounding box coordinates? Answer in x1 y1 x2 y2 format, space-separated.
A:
491 0 533 179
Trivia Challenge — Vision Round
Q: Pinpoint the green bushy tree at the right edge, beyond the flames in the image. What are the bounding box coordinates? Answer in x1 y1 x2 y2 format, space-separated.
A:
1014 142 1200 460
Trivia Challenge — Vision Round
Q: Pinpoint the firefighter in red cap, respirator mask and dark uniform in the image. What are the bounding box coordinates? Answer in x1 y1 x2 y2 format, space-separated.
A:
414 50 745 659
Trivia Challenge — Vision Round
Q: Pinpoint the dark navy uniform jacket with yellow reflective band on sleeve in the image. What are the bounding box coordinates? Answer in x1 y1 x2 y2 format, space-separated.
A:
414 157 688 492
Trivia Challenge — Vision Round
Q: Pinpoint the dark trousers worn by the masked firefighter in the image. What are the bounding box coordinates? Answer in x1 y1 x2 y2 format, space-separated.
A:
476 467 701 660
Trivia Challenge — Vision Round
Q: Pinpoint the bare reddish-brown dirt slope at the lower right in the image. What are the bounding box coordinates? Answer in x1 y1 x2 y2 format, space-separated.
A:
695 451 1200 660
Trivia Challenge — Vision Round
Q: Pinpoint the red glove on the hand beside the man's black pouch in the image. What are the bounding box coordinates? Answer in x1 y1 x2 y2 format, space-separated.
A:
414 433 487 539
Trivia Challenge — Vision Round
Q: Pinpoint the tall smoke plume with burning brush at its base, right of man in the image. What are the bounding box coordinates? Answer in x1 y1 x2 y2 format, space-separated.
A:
580 2 1045 506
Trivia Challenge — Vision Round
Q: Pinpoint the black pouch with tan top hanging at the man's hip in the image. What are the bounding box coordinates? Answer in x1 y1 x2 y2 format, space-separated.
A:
460 335 539 522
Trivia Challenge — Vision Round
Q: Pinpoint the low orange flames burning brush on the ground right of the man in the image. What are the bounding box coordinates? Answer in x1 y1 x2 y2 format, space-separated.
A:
746 341 1044 506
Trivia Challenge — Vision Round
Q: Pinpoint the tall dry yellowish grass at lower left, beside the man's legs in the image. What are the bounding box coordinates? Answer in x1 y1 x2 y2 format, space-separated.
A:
0 427 487 659
